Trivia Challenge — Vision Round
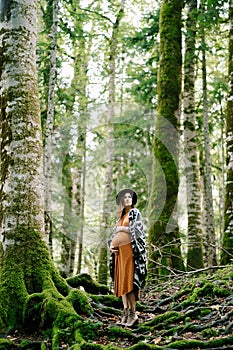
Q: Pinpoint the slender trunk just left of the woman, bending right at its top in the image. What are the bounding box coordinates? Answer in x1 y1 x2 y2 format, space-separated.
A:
98 1 125 284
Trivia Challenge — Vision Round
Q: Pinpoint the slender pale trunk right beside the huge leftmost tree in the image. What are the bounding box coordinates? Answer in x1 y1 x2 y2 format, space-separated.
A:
44 0 58 256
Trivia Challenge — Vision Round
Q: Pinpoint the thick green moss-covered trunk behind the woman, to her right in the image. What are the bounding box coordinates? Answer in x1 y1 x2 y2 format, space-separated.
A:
148 0 184 276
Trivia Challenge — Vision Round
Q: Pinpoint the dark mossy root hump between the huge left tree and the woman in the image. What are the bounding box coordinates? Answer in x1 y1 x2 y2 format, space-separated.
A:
66 273 110 294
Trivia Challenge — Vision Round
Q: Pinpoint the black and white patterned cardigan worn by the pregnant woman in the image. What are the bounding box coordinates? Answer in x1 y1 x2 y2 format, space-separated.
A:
109 208 147 289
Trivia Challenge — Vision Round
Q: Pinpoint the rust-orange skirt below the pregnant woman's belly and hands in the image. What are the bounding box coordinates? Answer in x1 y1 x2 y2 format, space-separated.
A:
114 243 139 300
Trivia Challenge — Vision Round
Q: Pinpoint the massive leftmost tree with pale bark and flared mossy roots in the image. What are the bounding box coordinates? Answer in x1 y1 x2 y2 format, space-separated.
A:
0 0 88 349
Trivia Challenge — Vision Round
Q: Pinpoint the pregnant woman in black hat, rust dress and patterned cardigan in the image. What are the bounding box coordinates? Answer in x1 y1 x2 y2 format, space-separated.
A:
110 189 146 327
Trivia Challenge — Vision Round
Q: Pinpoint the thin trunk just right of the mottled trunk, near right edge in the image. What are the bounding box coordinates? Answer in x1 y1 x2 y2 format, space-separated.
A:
201 2 217 266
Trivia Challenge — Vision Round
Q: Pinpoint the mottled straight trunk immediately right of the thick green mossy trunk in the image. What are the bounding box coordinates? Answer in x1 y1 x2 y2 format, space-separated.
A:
183 0 203 269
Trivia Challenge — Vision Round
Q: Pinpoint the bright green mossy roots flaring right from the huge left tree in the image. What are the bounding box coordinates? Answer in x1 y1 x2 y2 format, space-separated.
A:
24 288 93 349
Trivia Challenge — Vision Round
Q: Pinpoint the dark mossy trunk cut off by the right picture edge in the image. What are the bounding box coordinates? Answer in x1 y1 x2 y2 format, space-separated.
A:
221 0 233 264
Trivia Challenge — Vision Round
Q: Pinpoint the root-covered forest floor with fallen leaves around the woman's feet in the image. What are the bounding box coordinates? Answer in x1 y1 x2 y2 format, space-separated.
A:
1 266 233 350
